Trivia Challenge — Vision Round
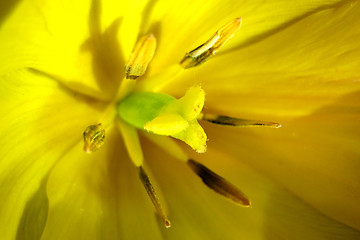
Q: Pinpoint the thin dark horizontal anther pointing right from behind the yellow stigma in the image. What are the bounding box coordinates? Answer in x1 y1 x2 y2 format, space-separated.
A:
200 113 281 128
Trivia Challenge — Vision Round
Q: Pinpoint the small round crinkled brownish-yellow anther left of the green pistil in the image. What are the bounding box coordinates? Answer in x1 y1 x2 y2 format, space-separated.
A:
83 123 105 153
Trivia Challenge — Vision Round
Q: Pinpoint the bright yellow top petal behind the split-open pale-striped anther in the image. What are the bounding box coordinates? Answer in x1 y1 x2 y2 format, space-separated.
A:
142 0 339 72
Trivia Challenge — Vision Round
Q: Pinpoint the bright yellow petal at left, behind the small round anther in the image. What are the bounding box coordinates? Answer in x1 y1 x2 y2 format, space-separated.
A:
0 70 103 239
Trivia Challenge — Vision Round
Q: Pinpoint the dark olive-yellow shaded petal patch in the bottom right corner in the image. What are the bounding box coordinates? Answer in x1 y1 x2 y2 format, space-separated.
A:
263 188 360 240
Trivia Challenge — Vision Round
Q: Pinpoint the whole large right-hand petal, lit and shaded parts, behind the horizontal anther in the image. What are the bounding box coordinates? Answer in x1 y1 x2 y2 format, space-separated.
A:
157 3 360 229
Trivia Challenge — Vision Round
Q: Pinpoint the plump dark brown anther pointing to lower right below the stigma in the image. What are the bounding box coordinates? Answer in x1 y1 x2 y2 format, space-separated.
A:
187 159 251 207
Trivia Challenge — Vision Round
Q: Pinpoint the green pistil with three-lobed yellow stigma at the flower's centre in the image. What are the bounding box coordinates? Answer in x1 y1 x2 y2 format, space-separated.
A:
117 86 207 153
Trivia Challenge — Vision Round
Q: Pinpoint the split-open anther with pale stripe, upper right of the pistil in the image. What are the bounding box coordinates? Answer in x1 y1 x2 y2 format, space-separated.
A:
180 18 241 69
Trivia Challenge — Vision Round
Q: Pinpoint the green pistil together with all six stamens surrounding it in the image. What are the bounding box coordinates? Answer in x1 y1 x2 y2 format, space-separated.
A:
84 18 280 227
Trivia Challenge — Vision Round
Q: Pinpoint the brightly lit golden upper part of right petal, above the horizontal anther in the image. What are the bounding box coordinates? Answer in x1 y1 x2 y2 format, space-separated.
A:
167 0 360 120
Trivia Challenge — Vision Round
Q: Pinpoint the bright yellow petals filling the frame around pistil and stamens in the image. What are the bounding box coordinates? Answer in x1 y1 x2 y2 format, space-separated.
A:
0 0 360 240
